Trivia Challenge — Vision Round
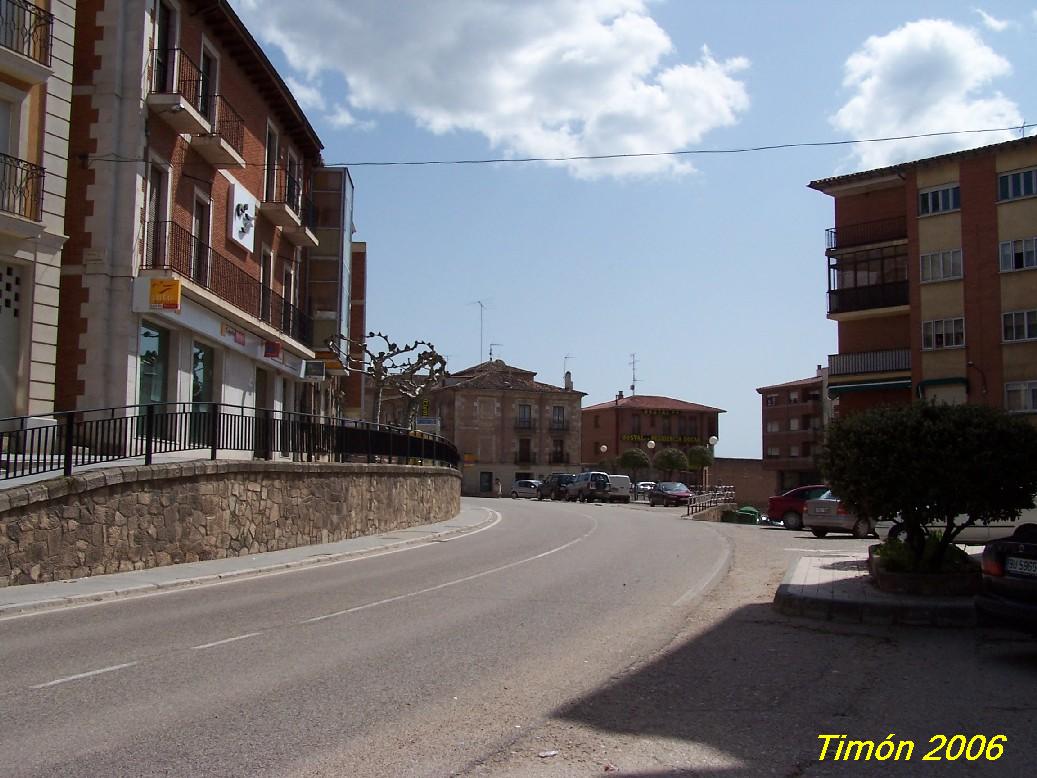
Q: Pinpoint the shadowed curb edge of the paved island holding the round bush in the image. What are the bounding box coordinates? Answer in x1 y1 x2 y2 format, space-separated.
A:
774 557 977 629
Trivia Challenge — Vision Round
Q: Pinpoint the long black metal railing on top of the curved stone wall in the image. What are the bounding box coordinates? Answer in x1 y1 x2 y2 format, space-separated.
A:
0 402 460 480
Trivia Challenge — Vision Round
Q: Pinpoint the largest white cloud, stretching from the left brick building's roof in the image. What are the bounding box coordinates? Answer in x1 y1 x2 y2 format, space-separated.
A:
229 0 749 177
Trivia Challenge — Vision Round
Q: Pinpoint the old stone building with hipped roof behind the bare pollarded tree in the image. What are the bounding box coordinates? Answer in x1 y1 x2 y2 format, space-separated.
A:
383 359 584 496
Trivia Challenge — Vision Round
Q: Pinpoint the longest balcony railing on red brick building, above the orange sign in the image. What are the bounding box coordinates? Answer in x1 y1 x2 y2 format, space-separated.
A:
140 222 312 344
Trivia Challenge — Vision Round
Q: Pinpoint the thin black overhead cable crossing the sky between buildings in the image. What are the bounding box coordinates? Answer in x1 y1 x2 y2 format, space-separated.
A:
80 123 1037 167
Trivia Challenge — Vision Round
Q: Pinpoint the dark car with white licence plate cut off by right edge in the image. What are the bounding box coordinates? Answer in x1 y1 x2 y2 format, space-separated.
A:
976 524 1037 635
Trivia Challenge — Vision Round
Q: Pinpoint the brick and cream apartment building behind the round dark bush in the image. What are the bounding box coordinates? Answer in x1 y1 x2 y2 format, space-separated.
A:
809 137 1037 421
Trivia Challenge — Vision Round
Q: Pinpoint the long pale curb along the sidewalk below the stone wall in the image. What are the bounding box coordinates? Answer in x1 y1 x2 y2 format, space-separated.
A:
0 513 496 618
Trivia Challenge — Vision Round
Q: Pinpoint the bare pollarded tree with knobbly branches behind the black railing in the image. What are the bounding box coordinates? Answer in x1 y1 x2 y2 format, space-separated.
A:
328 332 447 426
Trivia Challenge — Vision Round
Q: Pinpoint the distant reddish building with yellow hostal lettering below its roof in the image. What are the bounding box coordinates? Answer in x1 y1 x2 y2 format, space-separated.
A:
581 392 725 479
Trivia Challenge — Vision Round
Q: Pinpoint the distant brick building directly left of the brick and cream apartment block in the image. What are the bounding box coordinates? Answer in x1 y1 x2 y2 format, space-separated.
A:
756 367 831 494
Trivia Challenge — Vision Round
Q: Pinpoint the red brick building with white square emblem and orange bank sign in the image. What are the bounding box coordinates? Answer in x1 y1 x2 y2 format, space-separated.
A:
58 0 331 427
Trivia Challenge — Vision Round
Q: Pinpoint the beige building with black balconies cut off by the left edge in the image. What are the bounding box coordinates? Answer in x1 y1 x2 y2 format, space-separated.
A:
0 0 76 419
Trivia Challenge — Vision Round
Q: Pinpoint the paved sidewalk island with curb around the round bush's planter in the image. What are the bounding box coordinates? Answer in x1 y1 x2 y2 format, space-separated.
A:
774 554 976 627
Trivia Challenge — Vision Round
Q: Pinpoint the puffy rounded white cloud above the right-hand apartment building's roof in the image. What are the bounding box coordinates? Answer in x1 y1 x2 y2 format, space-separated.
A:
830 20 1022 169
